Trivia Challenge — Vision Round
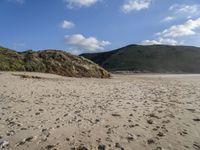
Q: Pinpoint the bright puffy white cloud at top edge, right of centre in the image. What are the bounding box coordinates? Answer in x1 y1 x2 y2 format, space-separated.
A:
121 0 151 13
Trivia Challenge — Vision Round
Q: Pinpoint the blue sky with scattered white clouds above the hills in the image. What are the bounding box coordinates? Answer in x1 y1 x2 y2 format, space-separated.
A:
0 0 200 54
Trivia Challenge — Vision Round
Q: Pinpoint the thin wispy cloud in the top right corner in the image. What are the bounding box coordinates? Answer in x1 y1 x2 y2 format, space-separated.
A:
169 4 200 14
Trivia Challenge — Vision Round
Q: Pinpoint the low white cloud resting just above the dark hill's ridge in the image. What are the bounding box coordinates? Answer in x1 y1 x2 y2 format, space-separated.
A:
142 38 178 45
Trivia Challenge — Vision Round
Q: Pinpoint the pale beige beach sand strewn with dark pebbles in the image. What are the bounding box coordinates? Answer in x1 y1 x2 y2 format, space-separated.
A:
0 72 200 150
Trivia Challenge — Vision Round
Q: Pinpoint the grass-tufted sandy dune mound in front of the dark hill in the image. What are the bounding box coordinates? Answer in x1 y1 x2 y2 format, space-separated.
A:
0 47 110 78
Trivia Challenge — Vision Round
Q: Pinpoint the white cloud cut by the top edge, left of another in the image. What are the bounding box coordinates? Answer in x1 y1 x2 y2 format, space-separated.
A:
64 0 99 8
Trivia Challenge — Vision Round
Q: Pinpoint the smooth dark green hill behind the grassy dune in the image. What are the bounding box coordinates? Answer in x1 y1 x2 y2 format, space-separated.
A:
81 45 200 73
